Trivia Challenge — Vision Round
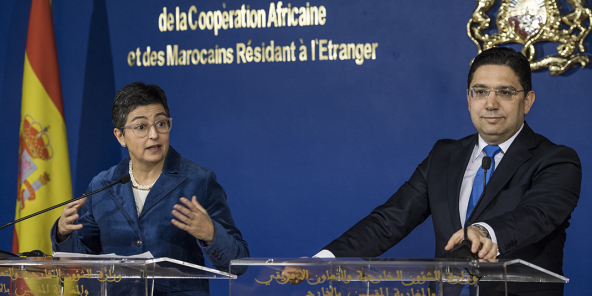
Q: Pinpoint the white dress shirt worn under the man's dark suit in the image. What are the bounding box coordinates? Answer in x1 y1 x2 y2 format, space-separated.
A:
313 123 524 258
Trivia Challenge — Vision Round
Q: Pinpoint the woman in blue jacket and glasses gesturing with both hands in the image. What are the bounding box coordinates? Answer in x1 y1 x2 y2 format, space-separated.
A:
52 82 249 295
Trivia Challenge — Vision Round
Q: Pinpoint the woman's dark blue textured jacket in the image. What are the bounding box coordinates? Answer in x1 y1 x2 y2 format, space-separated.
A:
51 147 249 295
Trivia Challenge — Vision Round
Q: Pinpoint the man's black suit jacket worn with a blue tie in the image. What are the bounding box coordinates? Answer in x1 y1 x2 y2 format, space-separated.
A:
324 123 582 292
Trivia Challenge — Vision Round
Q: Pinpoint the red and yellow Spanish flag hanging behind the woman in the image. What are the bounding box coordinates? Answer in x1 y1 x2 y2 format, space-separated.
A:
12 0 72 254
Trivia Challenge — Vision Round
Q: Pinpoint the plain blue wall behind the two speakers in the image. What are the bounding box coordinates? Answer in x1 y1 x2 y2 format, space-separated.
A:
0 0 592 295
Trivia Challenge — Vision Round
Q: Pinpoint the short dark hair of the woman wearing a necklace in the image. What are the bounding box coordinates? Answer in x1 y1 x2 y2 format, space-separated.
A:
111 81 171 134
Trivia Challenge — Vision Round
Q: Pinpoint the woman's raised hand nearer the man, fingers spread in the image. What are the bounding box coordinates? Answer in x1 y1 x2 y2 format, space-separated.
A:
171 195 214 244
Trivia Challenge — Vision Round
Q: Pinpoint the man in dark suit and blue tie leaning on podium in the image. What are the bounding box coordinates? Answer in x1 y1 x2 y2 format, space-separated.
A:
317 48 582 295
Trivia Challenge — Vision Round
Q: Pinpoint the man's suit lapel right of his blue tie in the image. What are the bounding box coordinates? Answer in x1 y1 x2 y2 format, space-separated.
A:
468 122 536 223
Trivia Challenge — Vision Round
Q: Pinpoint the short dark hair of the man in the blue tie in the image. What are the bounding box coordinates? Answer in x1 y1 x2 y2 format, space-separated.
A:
467 47 532 95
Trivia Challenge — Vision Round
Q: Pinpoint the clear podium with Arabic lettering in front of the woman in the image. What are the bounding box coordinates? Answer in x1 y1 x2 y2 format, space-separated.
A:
0 257 236 296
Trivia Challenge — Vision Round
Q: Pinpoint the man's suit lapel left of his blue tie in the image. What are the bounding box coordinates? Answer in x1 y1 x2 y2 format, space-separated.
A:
448 135 477 229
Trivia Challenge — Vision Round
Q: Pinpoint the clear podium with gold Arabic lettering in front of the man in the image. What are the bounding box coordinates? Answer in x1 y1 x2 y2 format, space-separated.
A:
230 258 569 296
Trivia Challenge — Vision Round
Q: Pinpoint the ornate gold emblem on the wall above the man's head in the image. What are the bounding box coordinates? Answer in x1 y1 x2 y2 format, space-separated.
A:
467 0 592 75
